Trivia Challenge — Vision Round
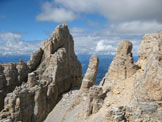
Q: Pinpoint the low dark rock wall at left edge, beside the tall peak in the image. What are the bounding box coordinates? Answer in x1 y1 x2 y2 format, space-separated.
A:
0 61 29 110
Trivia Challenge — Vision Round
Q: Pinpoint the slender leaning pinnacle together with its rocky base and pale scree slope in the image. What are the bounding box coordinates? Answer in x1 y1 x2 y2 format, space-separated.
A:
45 56 103 122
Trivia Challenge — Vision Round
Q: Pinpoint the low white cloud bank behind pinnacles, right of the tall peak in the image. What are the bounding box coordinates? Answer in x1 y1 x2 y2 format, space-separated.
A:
72 27 141 56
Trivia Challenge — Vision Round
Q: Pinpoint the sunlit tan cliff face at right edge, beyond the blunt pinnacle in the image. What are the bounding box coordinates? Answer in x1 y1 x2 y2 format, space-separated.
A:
102 32 162 122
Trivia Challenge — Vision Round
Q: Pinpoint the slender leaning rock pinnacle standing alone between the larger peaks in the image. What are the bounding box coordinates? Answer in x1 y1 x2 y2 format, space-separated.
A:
80 56 99 91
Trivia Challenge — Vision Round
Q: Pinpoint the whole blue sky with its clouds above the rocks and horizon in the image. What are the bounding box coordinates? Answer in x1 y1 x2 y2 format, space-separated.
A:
0 0 162 55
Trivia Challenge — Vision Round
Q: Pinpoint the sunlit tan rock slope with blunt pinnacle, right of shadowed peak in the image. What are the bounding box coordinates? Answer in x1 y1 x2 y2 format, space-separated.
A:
45 31 162 122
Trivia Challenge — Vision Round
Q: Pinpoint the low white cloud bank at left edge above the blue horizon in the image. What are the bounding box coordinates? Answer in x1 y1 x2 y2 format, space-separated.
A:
0 32 40 55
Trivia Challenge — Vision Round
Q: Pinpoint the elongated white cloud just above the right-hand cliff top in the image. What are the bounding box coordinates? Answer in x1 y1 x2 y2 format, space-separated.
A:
108 21 162 35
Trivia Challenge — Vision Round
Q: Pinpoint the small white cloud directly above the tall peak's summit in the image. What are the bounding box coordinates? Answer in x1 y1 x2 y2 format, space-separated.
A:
36 2 76 23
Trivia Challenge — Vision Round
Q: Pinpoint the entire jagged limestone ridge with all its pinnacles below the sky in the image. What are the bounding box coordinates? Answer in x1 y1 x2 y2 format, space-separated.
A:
0 25 162 122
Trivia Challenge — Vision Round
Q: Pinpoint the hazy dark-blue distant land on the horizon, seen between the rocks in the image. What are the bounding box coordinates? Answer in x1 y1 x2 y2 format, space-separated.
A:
0 55 138 84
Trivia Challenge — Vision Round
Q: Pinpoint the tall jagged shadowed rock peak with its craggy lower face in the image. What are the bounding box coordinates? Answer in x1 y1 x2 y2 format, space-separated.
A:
0 25 82 122
